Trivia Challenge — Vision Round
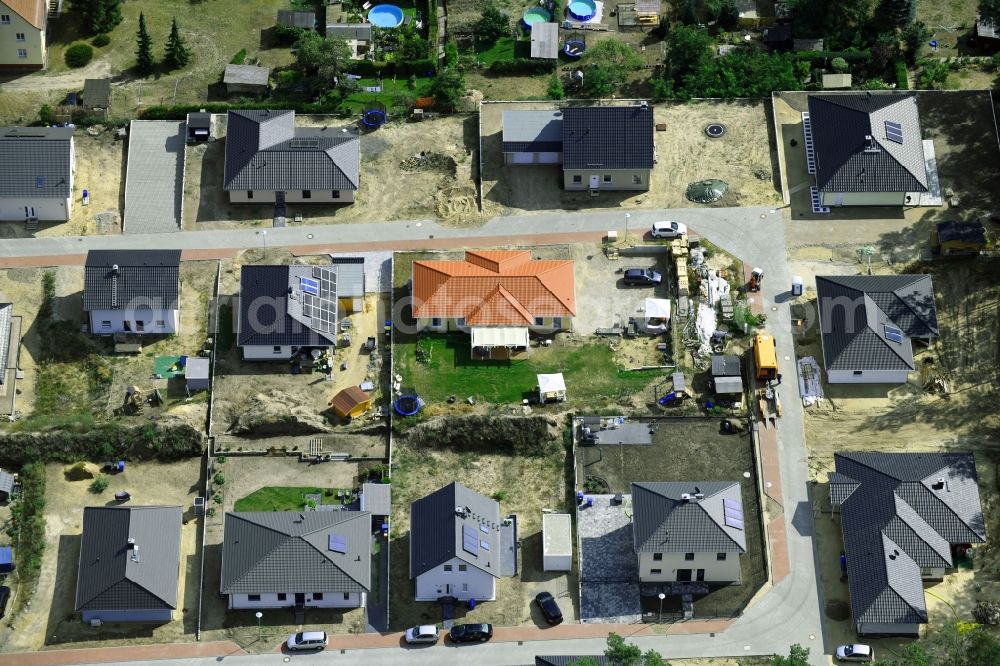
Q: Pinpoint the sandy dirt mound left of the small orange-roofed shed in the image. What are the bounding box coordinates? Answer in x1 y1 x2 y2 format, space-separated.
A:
227 389 330 437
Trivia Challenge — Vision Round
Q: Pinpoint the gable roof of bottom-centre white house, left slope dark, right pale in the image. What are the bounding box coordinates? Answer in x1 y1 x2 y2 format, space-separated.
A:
410 481 501 578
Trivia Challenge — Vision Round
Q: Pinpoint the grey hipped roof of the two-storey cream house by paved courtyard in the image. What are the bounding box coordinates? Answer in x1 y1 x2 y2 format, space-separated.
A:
632 481 747 553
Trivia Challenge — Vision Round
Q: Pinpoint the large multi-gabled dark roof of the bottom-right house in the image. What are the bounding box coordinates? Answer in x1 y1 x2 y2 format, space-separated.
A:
830 451 986 624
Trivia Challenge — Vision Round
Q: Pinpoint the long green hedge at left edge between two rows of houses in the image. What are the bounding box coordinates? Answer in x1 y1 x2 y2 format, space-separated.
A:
0 423 204 467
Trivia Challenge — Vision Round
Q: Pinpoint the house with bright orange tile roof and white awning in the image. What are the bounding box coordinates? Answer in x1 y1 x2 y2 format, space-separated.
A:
412 250 576 358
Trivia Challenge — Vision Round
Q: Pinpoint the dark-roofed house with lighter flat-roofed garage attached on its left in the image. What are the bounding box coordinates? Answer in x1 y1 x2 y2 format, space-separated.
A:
502 103 656 193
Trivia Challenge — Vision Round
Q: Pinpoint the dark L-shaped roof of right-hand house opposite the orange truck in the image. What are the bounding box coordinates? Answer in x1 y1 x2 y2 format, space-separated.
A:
816 275 938 371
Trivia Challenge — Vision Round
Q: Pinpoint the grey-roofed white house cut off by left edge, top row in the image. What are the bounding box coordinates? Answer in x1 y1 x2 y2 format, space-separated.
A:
0 127 76 222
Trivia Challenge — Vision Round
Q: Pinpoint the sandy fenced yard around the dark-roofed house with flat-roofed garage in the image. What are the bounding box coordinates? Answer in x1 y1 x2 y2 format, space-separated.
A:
481 102 780 215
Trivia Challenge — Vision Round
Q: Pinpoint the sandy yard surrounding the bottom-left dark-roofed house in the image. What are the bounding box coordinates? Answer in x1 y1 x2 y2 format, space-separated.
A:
0 458 201 652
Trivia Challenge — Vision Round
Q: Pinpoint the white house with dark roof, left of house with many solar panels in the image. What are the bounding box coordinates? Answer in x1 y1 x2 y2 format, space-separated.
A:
83 250 181 335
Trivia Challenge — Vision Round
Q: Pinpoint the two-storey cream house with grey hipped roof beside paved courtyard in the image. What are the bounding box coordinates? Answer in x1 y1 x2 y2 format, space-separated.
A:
632 481 747 590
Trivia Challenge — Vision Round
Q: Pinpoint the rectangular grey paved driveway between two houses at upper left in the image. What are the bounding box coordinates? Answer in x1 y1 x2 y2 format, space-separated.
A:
122 120 187 234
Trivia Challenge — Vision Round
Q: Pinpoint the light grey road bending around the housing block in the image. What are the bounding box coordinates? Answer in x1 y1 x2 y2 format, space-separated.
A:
0 208 835 666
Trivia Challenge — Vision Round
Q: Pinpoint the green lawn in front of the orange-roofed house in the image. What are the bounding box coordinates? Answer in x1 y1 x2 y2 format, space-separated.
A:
393 334 662 404
